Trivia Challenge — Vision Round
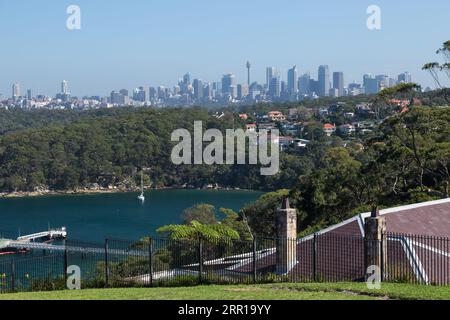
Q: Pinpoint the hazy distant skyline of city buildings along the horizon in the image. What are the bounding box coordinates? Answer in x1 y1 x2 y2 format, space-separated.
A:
0 62 412 109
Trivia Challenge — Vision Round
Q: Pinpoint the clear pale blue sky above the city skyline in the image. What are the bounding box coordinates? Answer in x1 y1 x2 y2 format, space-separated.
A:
0 0 450 96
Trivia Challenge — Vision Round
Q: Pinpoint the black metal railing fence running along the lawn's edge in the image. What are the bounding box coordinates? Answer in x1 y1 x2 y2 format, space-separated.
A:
0 233 450 293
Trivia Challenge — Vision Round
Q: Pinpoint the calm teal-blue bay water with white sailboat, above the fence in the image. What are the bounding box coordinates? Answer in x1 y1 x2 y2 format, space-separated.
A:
0 190 262 242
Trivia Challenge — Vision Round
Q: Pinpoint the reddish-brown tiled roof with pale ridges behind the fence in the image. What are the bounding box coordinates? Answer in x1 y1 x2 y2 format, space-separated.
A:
183 199 450 283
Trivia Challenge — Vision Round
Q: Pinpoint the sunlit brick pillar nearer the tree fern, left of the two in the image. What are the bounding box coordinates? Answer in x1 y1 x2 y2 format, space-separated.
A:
276 198 297 275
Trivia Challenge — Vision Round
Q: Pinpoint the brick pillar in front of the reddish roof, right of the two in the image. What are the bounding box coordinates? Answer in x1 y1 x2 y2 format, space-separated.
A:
364 208 387 279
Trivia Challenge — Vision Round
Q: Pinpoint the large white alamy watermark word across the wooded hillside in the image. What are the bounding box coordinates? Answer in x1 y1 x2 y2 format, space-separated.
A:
172 121 280 176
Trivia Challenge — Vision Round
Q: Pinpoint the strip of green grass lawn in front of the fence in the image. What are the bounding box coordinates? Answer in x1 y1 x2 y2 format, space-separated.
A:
0 283 450 300
